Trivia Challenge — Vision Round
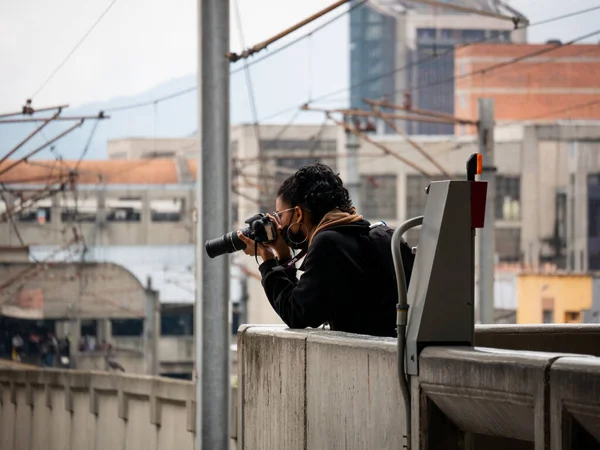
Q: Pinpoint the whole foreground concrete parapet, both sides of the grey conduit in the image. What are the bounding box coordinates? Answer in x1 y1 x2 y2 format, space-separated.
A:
238 326 600 450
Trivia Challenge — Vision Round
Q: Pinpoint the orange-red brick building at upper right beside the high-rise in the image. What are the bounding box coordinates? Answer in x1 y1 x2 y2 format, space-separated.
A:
454 43 600 135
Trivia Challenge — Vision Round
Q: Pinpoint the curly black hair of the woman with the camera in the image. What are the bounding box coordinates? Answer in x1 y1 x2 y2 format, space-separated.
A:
277 163 352 223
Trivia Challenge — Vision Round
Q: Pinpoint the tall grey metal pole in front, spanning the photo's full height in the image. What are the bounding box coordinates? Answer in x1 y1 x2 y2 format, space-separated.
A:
195 0 231 450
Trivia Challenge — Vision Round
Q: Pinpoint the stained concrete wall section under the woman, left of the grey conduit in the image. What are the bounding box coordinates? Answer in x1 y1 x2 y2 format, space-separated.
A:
238 326 403 450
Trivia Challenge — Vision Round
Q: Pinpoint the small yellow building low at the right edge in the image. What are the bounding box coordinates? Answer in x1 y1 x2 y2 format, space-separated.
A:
517 274 592 324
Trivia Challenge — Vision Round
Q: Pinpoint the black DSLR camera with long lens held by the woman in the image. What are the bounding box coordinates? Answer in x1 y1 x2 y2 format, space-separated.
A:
204 213 277 258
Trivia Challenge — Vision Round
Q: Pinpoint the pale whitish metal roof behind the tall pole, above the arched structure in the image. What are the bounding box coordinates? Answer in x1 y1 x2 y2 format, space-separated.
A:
30 245 241 303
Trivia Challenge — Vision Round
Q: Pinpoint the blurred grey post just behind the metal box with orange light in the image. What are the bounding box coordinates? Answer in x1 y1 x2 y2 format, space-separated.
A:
477 98 496 323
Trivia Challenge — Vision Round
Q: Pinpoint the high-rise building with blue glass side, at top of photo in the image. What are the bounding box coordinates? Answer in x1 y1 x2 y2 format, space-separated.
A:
350 0 526 135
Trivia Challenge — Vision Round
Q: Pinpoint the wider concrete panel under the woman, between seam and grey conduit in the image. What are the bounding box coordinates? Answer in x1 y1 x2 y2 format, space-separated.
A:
306 332 405 450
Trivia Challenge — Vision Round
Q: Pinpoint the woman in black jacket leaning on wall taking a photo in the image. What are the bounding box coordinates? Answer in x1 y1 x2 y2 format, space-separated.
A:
238 163 412 336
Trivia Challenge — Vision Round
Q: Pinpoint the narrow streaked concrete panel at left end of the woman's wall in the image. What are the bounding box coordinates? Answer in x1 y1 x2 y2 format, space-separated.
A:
238 326 310 450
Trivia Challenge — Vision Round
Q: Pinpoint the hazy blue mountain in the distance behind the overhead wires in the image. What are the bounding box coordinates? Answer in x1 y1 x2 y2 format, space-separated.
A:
0 21 349 163
